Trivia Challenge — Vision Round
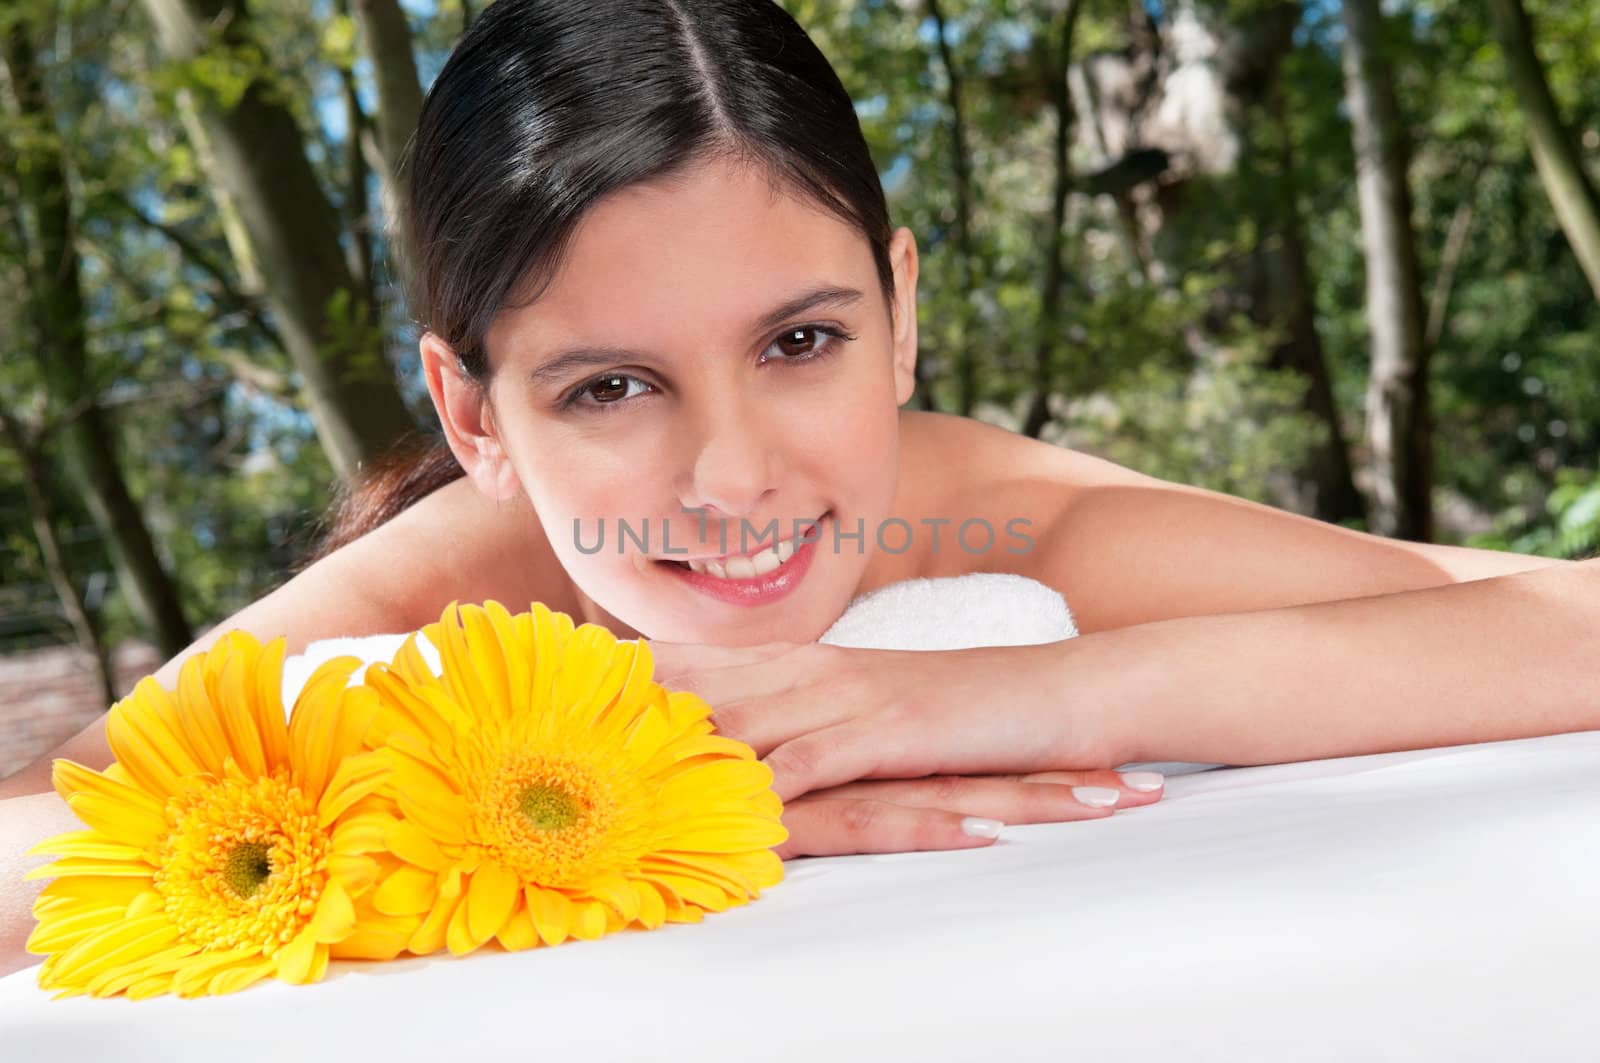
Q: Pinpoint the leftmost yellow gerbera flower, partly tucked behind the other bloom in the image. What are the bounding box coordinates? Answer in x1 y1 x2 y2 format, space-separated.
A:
27 631 416 997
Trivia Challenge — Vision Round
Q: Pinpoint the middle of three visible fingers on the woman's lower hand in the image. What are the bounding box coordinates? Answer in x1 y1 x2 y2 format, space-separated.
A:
806 775 1118 823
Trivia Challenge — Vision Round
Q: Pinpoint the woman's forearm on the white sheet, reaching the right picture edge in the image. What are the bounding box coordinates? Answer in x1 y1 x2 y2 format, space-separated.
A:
1088 560 1600 764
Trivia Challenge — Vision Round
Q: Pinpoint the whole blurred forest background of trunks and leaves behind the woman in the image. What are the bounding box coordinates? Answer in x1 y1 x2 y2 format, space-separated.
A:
0 0 1600 700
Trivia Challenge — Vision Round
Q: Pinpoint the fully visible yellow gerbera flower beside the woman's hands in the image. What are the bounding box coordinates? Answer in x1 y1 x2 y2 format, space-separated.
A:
366 602 789 954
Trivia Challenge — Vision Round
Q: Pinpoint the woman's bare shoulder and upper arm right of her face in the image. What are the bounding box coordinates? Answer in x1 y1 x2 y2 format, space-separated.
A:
906 413 1568 632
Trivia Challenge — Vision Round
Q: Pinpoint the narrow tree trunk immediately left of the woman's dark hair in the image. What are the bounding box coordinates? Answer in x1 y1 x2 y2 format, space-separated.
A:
350 0 422 290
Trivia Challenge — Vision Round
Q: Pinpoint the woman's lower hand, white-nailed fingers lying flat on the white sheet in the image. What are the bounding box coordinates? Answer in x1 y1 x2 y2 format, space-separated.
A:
774 772 1163 860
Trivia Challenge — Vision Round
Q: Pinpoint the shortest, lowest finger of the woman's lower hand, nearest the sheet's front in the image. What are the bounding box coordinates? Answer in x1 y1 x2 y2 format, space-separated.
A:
773 799 1005 860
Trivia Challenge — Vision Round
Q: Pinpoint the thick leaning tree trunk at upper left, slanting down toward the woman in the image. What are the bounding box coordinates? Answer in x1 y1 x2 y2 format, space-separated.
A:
146 0 414 477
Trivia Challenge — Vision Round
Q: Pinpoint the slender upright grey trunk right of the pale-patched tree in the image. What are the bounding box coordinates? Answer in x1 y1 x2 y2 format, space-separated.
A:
1341 0 1434 541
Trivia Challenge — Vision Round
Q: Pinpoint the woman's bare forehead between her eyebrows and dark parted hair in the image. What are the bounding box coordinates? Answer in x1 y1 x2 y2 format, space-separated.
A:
490 163 875 351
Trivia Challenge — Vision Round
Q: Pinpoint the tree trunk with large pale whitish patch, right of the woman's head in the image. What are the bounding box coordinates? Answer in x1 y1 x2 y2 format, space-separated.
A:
1069 0 1365 522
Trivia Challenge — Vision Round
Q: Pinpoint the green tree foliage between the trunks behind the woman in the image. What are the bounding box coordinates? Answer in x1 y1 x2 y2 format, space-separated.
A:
0 0 1600 659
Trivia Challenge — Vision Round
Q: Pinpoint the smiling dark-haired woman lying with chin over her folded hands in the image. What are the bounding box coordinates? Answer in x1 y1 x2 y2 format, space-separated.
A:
0 0 1600 973
